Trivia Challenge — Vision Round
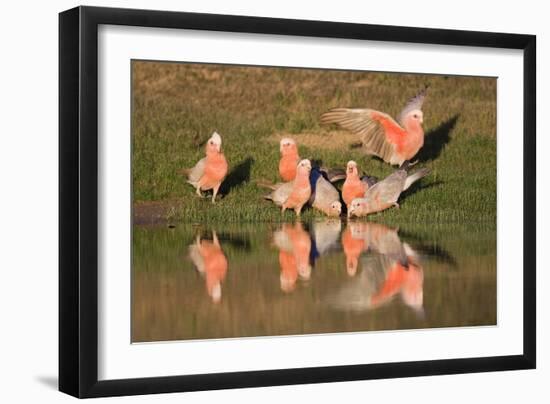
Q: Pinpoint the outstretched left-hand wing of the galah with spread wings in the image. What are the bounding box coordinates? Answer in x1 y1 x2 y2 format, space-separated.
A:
321 108 405 162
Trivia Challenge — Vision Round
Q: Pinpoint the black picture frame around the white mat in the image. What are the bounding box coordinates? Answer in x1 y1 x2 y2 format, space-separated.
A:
59 7 536 398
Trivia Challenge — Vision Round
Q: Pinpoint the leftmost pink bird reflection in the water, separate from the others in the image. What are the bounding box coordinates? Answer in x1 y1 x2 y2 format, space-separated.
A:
189 232 227 303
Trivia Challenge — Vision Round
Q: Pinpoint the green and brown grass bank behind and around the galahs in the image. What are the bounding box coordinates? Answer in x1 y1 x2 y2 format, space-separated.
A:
132 62 496 223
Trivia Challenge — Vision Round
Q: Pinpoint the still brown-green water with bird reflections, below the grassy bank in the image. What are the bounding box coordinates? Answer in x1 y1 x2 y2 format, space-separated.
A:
132 220 496 342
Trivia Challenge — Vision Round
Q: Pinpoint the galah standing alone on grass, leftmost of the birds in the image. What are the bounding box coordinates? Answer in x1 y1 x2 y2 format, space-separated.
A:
186 132 228 203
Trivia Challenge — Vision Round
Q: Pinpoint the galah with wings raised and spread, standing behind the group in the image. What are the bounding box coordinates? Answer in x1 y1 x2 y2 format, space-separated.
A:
321 87 427 166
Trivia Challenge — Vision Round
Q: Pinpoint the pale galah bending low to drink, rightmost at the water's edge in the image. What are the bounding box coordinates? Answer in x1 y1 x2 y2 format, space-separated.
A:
348 163 430 217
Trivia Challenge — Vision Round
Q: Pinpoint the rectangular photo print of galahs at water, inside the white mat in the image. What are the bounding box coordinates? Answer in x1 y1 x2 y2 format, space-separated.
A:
130 60 497 343
